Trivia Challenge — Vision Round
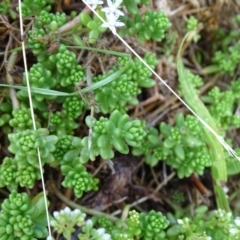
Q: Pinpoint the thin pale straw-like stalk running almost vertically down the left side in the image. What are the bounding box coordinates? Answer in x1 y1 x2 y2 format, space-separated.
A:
18 0 51 237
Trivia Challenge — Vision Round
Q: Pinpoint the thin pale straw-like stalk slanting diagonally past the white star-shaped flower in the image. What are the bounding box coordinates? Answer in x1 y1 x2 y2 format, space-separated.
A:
83 0 240 161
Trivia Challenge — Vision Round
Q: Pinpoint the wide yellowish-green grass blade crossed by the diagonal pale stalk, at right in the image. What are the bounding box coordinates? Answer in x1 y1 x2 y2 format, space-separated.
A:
177 31 230 211
